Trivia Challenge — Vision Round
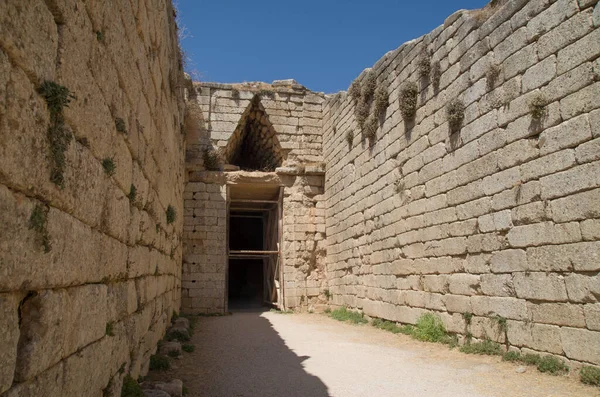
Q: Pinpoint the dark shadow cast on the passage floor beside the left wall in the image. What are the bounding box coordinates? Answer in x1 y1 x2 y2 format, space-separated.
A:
149 311 329 397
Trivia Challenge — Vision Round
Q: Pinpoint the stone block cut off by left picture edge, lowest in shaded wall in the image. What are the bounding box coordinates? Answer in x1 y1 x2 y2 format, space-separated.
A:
0 294 19 393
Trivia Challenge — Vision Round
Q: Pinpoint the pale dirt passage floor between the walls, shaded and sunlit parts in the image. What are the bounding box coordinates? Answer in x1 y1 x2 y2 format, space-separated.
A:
149 312 598 397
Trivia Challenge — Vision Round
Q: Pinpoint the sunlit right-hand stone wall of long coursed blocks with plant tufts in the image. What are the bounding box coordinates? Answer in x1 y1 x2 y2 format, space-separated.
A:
323 0 600 364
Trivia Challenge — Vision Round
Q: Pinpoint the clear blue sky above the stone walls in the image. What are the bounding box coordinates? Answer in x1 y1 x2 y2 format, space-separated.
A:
176 0 487 93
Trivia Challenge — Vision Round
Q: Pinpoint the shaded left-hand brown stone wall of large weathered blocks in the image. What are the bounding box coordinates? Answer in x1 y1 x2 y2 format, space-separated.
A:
0 0 184 397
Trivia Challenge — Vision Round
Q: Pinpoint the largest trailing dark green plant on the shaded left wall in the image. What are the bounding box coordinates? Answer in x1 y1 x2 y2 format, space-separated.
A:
38 80 75 188
